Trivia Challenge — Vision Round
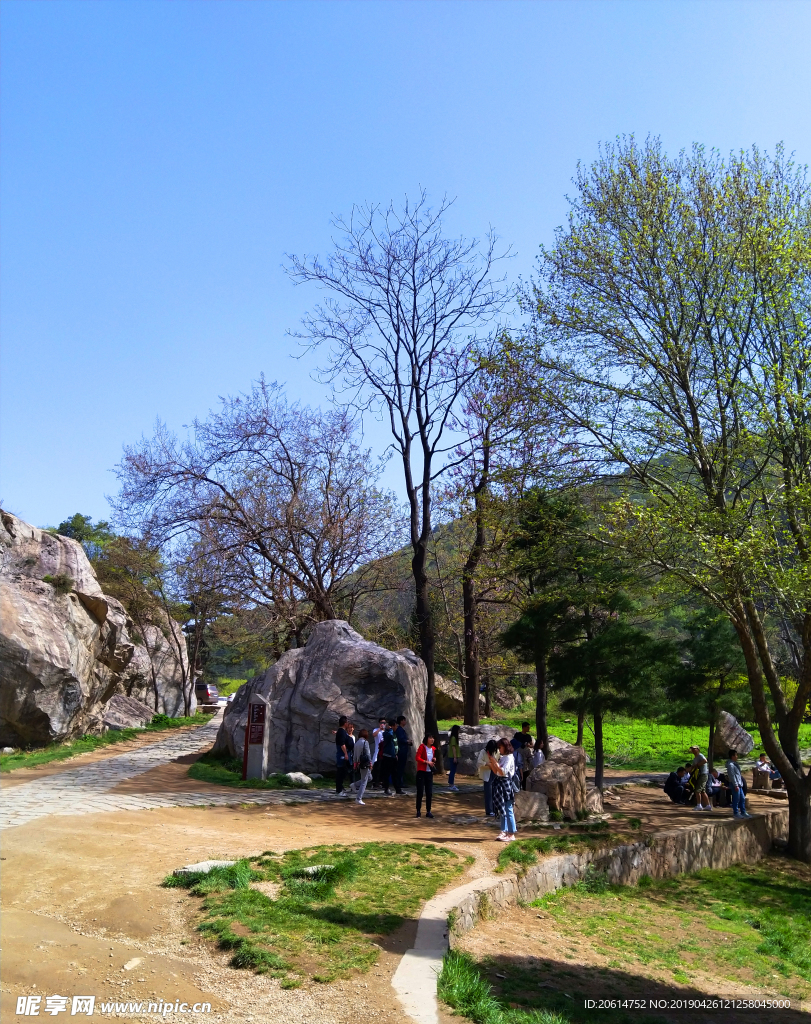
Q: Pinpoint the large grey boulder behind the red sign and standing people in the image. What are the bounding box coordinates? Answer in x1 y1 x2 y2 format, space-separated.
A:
214 618 428 775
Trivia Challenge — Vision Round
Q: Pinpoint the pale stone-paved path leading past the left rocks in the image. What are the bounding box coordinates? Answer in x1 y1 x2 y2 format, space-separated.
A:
0 712 387 828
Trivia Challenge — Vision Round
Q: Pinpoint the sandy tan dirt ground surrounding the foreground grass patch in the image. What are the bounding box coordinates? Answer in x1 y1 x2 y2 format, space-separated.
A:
0 745 786 1024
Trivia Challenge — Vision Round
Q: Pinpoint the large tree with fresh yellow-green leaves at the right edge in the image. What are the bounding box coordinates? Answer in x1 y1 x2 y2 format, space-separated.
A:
510 138 811 862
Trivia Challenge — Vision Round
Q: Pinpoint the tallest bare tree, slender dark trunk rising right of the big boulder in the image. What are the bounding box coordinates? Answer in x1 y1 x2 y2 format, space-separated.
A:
289 191 507 753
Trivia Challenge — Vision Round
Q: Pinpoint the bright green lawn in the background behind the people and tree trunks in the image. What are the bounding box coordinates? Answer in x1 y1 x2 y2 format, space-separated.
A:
439 705 811 771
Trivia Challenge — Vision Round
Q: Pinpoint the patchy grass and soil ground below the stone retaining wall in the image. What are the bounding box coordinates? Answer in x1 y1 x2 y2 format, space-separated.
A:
439 856 811 1024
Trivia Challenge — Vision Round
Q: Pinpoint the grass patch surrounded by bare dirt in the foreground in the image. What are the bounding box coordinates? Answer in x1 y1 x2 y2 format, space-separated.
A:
164 843 464 987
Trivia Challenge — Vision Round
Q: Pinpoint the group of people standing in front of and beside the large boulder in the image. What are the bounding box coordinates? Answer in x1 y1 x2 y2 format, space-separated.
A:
335 715 544 843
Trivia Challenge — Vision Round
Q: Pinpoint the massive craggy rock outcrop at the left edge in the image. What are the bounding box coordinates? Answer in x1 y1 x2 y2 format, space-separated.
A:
0 511 196 746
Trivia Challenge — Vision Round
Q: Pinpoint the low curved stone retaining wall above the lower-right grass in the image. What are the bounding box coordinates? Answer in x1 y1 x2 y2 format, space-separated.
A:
449 807 788 947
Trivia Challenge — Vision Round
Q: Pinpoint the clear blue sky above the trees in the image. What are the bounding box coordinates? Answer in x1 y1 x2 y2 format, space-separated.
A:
0 0 811 525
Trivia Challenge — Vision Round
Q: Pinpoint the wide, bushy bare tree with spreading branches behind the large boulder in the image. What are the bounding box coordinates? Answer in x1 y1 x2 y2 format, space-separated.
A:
115 381 397 643
